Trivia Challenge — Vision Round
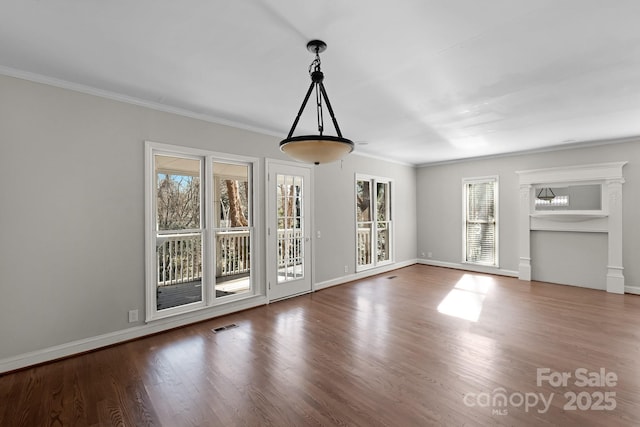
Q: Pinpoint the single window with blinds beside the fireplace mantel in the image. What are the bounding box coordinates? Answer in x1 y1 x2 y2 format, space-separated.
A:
463 177 498 267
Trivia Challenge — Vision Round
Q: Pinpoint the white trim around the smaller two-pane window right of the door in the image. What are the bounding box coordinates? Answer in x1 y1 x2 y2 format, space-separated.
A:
353 173 395 273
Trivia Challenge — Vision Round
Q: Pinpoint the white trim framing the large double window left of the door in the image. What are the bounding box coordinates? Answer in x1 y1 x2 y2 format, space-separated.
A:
144 141 265 323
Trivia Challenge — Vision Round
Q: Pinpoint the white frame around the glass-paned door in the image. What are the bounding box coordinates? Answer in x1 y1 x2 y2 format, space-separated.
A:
264 158 315 303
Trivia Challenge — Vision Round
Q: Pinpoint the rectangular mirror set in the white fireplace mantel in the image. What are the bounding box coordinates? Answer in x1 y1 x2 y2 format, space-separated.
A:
535 184 602 211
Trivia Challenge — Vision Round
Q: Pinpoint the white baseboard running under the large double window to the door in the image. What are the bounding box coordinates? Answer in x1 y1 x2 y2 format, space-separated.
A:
0 296 267 374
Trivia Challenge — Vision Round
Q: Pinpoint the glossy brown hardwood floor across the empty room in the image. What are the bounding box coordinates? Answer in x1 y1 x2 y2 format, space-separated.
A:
0 265 640 427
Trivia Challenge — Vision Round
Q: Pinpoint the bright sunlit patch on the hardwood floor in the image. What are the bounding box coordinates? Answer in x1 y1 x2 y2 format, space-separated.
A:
438 274 494 322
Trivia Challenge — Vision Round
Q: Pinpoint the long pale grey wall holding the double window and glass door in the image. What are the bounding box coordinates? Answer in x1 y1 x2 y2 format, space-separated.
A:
0 76 416 372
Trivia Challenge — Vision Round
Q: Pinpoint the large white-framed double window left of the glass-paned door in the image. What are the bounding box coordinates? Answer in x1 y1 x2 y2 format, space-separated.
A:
146 143 256 320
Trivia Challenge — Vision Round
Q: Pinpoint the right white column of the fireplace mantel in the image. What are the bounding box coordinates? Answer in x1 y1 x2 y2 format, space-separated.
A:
605 178 624 294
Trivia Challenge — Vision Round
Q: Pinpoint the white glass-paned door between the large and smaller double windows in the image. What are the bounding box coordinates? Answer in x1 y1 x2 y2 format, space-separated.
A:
267 162 311 301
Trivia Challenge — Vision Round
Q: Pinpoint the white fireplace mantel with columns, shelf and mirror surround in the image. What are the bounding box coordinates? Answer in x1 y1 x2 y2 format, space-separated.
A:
516 162 627 294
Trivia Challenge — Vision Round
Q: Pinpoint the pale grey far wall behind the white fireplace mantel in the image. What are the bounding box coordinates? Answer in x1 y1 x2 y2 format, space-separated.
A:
417 138 640 286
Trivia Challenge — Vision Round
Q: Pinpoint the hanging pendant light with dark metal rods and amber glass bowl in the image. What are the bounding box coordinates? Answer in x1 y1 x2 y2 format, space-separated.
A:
280 40 354 165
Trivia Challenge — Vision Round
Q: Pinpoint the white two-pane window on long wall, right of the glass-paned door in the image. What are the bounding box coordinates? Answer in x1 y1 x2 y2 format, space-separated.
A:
356 175 393 271
